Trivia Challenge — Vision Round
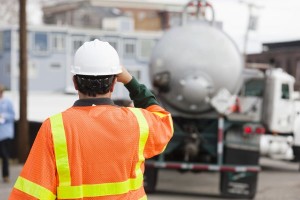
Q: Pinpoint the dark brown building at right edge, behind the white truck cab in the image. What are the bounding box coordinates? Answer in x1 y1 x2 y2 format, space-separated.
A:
247 41 300 90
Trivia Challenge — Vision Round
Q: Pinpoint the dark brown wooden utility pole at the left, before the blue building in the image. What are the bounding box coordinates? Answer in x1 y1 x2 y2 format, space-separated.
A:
18 0 29 163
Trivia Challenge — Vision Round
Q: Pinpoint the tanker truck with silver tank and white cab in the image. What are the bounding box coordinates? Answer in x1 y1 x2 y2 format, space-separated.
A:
144 1 300 198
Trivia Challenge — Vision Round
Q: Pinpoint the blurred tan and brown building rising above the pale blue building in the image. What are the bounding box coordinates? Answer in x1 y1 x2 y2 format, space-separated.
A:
43 0 189 31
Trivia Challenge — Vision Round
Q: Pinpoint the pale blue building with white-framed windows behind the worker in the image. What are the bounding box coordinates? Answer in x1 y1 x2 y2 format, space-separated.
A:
0 26 162 98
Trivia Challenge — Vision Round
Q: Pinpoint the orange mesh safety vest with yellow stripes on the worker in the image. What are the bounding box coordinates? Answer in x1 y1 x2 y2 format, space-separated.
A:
10 105 173 200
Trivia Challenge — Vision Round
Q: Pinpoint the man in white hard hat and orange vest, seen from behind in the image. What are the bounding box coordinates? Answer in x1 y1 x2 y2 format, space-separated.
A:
9 39 173 200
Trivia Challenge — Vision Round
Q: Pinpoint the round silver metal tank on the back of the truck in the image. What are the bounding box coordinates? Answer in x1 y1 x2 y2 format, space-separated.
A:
150 21 244 113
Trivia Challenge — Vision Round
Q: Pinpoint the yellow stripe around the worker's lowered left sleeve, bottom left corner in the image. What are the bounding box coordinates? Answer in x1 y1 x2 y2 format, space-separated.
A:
14 176 56 200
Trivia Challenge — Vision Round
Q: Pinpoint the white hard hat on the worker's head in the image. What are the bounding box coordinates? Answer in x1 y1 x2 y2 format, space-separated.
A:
71 39 122 76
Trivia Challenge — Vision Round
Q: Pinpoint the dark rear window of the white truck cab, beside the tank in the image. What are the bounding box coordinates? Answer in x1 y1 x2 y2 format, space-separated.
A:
243 79 264 97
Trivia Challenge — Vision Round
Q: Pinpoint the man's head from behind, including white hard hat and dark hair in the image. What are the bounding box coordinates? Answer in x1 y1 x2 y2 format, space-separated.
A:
71 39 122 97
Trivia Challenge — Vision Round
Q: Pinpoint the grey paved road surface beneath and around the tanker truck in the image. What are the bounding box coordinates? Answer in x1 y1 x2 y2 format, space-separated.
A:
0 159 300 200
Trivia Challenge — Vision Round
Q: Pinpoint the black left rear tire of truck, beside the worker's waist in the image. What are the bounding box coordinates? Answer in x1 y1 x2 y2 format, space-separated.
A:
144 167 158 193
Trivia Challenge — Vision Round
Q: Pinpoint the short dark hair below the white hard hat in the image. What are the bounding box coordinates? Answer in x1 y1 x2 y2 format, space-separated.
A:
74 75 116 97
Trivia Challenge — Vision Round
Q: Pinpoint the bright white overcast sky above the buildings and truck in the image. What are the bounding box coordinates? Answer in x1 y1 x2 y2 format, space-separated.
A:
28 0 300 53
